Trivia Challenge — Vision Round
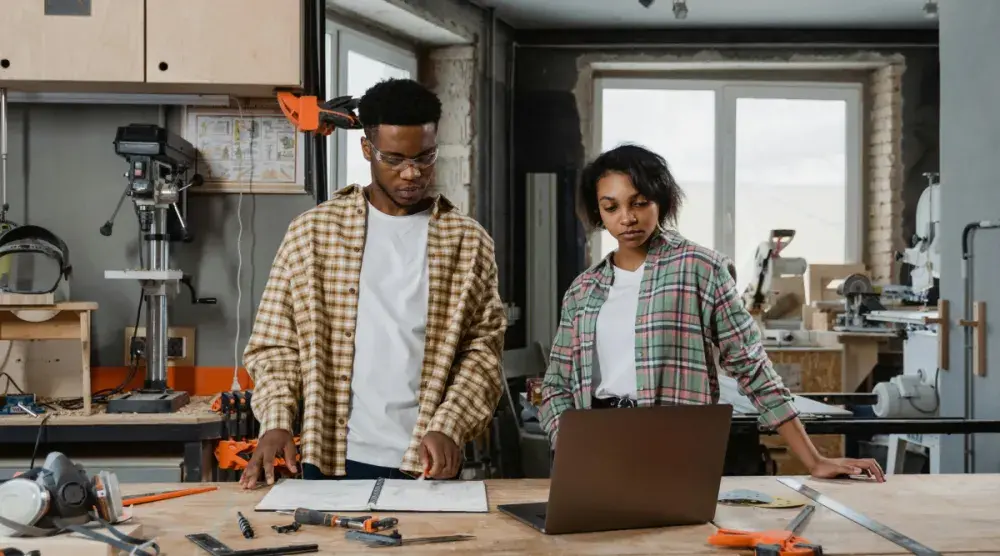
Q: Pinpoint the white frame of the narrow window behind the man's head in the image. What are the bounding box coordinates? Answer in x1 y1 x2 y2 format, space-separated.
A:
325 18 417 198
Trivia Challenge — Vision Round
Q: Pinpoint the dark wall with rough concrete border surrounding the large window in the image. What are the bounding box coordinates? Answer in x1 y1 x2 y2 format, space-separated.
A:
509 31 938 348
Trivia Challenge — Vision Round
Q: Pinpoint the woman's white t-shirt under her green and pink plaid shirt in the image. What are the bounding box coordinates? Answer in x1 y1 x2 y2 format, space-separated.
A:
593 263 646 400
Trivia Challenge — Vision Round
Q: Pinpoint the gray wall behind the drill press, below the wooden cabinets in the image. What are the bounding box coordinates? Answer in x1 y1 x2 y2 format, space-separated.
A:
8 104 315 366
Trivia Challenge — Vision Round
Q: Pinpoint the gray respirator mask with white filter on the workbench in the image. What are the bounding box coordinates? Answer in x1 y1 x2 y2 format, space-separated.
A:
0 452 160 556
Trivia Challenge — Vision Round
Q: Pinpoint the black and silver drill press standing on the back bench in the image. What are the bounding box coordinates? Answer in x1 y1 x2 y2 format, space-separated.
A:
101 124 215 413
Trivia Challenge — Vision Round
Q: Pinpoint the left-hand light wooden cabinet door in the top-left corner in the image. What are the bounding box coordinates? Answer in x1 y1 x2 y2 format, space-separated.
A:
0 0 145 82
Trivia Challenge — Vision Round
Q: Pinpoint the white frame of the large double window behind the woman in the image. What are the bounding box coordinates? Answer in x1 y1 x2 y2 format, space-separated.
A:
590 76 867 264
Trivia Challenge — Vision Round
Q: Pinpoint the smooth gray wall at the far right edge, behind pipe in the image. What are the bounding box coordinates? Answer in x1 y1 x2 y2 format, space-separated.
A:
940 0 1000 473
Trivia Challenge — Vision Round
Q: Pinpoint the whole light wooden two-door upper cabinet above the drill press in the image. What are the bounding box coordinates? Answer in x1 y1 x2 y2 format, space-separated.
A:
0 0 304 92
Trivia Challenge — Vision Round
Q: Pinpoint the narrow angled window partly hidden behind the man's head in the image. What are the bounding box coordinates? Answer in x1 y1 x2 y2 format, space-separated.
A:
326 20 417 198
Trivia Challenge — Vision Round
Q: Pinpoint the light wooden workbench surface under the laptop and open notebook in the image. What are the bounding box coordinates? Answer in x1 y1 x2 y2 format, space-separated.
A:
123 474 1000 556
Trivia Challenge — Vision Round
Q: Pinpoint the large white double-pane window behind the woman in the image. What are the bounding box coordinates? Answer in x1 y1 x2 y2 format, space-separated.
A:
593 78 862 269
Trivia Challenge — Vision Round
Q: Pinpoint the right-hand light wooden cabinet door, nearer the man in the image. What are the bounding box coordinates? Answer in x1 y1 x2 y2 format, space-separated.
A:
146 0 303 86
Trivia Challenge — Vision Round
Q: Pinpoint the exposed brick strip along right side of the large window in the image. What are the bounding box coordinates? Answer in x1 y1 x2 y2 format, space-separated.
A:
864 63 905 284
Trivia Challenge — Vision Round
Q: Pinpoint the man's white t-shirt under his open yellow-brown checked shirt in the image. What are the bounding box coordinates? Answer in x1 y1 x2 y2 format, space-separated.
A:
347 204 430 468
